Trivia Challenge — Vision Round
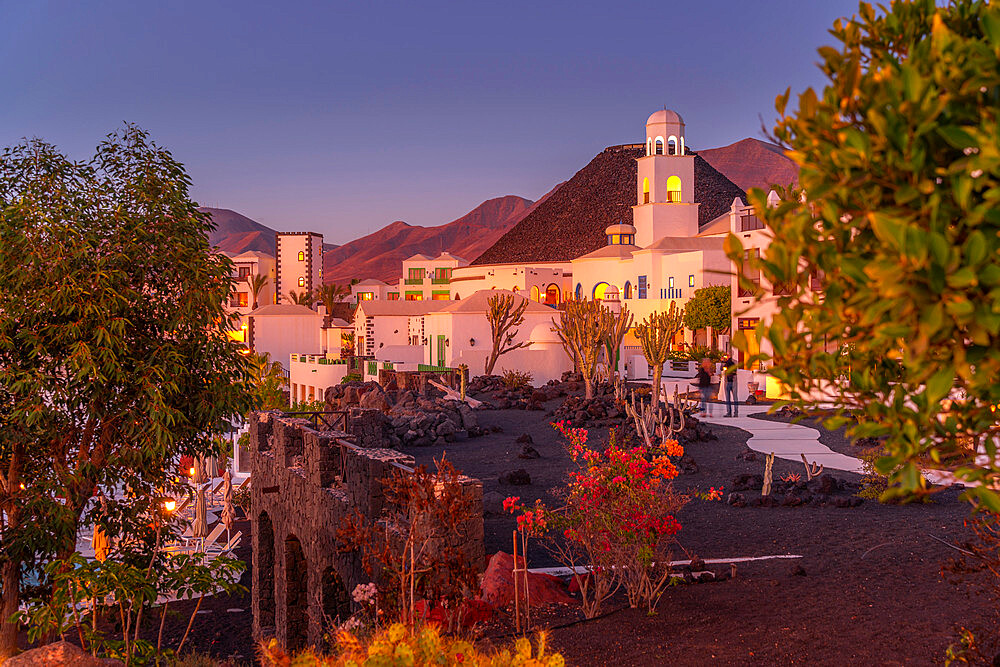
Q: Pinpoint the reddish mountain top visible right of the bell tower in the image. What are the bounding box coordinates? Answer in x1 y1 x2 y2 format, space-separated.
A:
698 137 799 190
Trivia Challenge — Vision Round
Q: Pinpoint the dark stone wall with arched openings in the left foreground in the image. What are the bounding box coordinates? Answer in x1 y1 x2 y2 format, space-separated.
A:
249 412 485 650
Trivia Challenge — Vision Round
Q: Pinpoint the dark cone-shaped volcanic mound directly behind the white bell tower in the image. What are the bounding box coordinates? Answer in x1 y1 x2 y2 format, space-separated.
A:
472 144 746 264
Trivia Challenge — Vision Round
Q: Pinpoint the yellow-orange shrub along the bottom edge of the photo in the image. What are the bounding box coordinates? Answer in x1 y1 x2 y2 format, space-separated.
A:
257 623 566 667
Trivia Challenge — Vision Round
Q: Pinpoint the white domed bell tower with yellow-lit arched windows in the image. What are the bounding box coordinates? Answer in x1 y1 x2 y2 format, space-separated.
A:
632 108 698 248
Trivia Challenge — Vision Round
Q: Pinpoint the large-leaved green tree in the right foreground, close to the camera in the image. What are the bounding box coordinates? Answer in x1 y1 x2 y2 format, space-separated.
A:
727 0 1000 500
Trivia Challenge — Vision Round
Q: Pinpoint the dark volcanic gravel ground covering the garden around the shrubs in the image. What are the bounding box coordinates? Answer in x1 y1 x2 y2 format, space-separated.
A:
95 401 993 666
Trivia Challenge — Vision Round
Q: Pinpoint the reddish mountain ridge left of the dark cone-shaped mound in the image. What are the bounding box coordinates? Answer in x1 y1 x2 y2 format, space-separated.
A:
323 194 544 283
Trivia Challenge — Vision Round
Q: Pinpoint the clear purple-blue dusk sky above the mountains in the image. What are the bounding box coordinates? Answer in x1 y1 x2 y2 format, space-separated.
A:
0 0 857 243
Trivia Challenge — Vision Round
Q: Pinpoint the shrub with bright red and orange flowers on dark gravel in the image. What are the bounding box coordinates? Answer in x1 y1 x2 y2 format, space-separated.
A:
504 422 722 617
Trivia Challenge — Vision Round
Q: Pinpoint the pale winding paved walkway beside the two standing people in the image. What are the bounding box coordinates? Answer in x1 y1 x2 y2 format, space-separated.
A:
702 412 863 474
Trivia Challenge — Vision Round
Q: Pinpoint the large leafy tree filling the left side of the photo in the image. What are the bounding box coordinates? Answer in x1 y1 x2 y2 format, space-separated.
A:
0 126 252 658
